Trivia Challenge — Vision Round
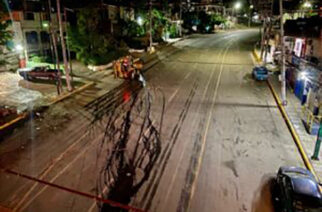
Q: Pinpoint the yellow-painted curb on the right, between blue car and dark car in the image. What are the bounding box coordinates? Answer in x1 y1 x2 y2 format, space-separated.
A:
267 80 320 182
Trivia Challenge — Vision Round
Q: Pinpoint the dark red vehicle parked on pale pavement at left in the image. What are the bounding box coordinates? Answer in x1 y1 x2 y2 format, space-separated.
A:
18 66 62 80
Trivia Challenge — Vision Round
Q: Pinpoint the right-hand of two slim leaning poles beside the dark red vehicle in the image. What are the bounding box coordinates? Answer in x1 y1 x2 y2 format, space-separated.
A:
56 0 73 91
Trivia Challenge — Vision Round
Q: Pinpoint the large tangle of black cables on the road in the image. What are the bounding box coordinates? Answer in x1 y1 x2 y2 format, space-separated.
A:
85 82 165 211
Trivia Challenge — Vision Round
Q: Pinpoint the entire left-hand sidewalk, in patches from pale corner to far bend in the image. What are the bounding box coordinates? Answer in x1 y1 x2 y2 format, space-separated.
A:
0 36 182 131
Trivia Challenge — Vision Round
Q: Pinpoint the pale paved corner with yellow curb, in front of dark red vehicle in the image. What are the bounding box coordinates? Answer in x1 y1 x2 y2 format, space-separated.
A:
0 72 89 136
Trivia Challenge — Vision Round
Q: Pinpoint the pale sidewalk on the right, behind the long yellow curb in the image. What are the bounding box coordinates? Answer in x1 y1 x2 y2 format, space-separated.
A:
270 76 322 180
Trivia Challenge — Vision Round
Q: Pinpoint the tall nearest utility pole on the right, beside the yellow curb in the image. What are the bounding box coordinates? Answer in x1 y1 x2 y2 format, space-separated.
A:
279 0 287 105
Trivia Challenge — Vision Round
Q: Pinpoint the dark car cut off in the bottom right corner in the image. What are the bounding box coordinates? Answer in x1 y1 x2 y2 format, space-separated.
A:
272 167 322 212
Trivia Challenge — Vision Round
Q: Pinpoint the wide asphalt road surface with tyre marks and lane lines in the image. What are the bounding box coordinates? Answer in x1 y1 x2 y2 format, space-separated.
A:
0 30 303 212
